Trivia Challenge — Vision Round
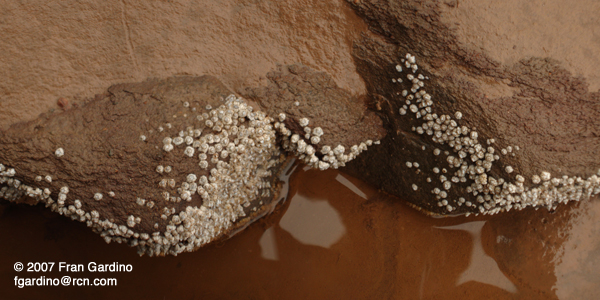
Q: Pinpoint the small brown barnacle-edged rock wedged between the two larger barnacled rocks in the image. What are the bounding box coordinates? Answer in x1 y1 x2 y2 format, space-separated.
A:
241 64 385 170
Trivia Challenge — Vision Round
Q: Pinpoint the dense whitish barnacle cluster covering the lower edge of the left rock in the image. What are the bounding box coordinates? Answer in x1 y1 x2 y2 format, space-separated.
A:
0 95 284 256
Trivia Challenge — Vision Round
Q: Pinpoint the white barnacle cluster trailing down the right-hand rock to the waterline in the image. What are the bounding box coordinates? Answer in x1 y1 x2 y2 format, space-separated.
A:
392 54 600 214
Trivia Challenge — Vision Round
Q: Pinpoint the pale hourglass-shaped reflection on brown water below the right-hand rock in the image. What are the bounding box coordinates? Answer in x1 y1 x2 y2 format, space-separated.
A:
436 221 517 293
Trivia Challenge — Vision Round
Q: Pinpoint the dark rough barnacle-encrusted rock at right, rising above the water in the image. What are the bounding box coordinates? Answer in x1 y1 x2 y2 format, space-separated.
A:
345 0 600 214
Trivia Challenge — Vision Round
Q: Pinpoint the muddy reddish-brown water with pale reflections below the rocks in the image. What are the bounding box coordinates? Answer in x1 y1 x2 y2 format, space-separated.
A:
0 166 600 299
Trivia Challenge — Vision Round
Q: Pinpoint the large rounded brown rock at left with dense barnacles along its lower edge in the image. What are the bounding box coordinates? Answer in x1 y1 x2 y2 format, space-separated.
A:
0 76 286 255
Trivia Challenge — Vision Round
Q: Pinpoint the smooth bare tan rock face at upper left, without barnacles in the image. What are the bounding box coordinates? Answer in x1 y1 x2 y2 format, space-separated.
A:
0 0 366 128
